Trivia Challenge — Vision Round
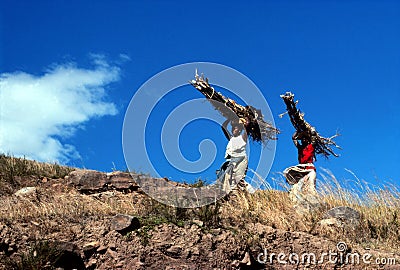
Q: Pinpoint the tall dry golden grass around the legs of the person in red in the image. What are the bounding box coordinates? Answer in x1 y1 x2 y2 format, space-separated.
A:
222 170 400 251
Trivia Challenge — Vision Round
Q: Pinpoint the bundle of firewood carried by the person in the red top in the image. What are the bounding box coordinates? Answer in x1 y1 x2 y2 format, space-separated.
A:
280 92 341 158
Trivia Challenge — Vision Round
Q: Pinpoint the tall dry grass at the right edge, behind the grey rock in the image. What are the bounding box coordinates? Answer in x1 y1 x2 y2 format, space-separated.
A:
321 170 400 250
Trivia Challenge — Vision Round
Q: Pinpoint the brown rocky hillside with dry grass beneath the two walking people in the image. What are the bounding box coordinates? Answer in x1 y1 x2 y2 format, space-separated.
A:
0 157 400 269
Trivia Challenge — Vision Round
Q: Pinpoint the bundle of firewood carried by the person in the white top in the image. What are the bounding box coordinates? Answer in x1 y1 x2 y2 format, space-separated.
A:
189 70 279 144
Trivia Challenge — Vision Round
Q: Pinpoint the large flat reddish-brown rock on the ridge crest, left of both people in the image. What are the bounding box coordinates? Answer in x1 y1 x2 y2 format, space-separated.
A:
66 170 109 193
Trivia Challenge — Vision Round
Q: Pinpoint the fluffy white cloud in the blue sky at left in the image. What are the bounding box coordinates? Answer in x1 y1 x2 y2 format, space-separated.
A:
0 58 120 163
